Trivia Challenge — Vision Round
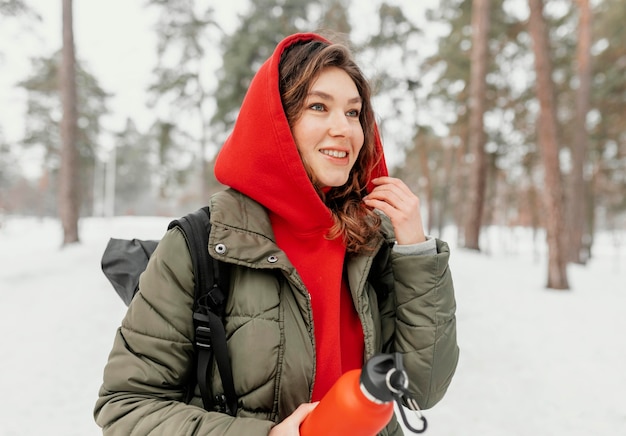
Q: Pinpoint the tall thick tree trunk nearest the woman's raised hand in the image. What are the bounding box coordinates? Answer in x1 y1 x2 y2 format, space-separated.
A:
465 0 490 250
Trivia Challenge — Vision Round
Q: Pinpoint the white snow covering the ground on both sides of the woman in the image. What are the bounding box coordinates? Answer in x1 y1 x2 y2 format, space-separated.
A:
0 217 626 436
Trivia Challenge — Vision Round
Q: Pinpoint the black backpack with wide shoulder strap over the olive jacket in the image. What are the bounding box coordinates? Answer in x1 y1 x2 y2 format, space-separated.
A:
102 207 237 416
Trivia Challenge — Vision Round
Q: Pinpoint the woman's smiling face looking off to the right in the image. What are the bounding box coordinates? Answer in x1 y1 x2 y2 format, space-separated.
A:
291 67 364 188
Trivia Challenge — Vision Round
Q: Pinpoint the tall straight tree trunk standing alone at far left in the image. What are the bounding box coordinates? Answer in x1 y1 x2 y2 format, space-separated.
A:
58 0 79 245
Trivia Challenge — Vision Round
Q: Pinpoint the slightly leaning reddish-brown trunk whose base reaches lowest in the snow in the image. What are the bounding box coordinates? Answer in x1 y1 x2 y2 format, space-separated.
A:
528 0 569 289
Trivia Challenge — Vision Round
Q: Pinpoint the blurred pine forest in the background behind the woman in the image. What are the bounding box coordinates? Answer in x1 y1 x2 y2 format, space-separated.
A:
0 0 626 290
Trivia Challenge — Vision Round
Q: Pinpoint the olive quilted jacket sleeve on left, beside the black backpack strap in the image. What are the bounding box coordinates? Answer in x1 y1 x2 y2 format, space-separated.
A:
94 230 274 436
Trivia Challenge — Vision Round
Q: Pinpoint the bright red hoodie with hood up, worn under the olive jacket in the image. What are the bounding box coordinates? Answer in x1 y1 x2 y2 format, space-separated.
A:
215 34 387 401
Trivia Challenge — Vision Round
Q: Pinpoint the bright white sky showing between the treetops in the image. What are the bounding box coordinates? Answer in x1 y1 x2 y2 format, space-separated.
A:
0 0 438 176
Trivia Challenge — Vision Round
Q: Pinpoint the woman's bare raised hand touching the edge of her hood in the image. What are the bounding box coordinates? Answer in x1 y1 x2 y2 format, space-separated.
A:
363 177 426 245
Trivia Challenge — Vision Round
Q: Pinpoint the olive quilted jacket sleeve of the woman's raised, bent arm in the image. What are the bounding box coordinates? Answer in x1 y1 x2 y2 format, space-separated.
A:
381 240 459 409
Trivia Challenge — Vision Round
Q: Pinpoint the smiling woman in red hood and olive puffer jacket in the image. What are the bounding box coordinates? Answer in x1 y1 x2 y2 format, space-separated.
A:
95 34 458 436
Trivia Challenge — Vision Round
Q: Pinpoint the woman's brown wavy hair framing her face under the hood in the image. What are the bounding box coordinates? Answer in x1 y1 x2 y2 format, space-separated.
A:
279 40 381 254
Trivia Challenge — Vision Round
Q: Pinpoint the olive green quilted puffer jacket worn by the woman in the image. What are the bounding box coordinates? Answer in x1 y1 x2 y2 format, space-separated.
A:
94 190 458 436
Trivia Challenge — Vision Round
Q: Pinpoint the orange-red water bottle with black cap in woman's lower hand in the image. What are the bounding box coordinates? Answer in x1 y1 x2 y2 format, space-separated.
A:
300 354 406 436
